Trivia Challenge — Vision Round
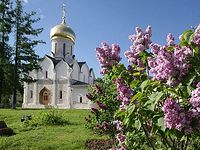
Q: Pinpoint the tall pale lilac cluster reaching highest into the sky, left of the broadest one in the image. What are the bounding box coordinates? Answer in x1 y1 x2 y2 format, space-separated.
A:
124 26 152 67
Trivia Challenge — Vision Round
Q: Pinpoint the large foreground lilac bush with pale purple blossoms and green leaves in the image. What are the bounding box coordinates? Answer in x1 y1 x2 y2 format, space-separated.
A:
87 25 200 150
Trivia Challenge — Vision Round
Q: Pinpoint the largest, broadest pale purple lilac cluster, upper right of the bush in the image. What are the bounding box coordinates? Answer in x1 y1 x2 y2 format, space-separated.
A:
148 34 192 86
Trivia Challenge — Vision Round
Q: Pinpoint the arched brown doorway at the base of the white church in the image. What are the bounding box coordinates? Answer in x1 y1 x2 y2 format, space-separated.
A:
40 87 50 105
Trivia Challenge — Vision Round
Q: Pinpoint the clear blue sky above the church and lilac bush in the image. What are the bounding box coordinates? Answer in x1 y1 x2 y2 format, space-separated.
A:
19 0 200 76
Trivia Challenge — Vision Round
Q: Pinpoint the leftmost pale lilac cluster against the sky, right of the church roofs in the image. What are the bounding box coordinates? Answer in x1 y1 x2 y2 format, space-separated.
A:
96 42 121 74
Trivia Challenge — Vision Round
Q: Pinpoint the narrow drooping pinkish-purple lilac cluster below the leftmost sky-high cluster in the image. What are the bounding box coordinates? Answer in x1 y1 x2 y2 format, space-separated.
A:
115 78 133 110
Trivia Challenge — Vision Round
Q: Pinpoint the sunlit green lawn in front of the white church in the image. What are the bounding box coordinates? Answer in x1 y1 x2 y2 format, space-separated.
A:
0 109 105 150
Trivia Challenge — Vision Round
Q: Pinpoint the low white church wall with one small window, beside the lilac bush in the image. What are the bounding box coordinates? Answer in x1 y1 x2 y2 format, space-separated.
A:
71 86 91 109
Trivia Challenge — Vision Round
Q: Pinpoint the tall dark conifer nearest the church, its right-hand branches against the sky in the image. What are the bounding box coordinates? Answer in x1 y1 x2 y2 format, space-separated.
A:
12 0 44 108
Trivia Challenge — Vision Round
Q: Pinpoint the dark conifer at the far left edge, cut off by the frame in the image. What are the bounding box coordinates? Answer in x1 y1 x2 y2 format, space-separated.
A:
0 0 13 106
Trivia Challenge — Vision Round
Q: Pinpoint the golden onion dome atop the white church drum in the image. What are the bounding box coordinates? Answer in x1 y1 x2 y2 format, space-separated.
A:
50 21 76 43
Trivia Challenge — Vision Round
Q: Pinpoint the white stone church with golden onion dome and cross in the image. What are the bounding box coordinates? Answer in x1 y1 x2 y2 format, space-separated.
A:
22 5 95 109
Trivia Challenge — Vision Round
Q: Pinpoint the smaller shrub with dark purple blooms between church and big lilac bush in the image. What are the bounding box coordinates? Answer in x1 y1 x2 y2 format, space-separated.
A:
85 76 119 138
